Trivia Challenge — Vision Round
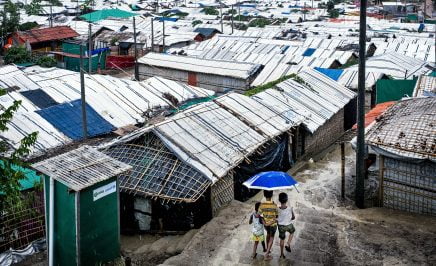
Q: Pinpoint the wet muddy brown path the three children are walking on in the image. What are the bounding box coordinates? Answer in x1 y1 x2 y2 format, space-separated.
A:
163 147 436 265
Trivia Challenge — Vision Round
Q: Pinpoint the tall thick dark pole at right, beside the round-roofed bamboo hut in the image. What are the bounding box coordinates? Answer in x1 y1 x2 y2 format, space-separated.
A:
355 0 367 208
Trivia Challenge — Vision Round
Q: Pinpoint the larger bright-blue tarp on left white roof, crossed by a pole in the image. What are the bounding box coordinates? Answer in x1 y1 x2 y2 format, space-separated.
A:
36 100 115 140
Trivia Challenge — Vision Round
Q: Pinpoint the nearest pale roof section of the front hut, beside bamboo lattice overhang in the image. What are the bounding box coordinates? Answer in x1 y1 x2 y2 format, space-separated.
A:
153 102 267 182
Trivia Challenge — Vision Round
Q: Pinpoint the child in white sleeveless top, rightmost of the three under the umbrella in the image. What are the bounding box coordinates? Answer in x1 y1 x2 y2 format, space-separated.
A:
277 193 295 258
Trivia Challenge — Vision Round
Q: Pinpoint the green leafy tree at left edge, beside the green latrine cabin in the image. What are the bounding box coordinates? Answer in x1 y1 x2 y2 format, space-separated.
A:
0 89 38 208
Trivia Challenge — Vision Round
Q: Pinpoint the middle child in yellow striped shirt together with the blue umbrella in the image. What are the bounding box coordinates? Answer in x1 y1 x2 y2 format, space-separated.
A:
243 171 298 260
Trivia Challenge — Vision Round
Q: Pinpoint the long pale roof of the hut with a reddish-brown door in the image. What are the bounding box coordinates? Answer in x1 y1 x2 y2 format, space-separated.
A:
138 53 260 79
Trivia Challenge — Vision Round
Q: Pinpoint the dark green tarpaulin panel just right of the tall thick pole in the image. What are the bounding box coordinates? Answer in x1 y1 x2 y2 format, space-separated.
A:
376 79 416 103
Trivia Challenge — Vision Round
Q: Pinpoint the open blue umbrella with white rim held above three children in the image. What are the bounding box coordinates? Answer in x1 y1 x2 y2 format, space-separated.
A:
243 171 298 191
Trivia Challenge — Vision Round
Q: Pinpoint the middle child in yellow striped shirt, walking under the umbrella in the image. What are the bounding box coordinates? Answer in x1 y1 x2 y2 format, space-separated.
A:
259 190 278 260
